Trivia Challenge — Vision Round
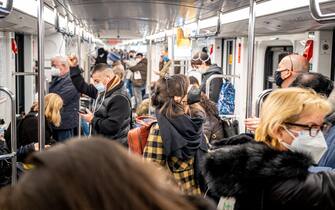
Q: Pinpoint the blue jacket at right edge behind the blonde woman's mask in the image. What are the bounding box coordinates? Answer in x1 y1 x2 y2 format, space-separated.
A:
319 113 335 168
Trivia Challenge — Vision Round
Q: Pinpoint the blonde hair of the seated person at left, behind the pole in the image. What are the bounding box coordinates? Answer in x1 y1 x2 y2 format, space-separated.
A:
44 93 63 127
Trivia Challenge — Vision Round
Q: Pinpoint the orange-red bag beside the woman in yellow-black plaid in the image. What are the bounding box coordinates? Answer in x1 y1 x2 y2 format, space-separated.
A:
128 116 157 155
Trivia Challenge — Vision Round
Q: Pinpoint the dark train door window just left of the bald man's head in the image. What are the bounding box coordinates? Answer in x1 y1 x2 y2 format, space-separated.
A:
263 46 293 90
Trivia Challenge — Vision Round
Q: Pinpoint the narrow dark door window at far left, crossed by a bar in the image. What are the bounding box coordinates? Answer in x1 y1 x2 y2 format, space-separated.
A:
15 34 25 113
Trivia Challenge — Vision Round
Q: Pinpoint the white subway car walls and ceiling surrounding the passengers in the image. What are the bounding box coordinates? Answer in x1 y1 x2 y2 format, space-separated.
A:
0 0 335 208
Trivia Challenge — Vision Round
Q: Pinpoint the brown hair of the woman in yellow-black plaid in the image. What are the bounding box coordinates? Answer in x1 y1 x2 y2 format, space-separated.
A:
151 74 190 118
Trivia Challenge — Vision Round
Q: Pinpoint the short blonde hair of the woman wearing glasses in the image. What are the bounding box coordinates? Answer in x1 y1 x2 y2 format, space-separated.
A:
255 88 332 149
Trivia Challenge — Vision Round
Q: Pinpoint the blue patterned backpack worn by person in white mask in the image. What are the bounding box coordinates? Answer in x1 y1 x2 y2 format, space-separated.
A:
217 79 235 116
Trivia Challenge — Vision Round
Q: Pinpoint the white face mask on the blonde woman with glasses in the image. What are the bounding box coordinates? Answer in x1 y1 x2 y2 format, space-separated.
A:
280 127 328 163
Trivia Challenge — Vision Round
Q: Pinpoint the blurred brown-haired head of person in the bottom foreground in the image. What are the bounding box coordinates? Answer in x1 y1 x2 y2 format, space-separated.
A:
0 137 215 210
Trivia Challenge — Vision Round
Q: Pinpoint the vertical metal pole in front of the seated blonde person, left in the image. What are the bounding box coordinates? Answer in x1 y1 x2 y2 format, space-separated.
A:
37 0 45 151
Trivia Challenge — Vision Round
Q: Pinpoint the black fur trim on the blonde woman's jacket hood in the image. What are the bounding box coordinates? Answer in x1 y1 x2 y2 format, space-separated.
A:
203 143 313 197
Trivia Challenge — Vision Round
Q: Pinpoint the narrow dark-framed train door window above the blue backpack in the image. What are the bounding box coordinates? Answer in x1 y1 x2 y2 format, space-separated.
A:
222 39 236 75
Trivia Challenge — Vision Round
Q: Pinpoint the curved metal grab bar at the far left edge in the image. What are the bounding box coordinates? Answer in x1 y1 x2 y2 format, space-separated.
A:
0 86 17 186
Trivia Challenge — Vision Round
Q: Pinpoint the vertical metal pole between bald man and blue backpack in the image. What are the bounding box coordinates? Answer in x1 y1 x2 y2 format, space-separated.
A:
246 0 256 118
